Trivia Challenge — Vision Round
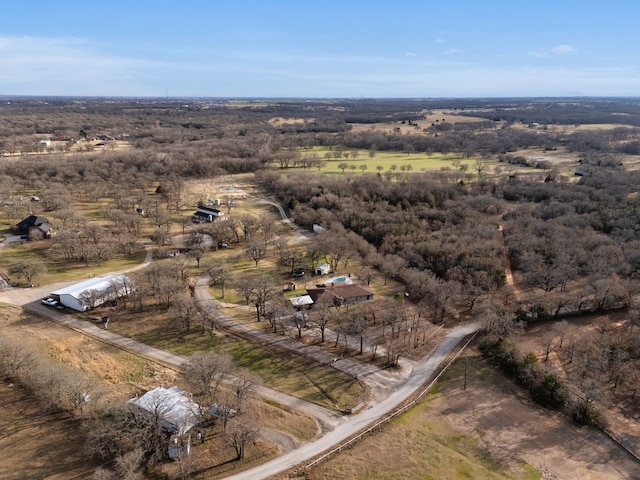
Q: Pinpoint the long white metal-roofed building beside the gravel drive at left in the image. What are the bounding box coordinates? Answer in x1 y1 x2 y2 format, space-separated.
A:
51 275 133 312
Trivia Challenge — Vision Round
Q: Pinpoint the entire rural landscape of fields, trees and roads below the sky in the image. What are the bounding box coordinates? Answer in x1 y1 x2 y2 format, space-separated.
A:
0 95 640 480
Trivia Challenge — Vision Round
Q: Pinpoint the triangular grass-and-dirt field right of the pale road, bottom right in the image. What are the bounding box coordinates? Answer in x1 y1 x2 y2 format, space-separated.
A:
308 353 640 480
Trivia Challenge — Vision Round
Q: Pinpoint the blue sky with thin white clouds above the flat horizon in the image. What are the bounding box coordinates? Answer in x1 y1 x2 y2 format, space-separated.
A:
0 0 640 98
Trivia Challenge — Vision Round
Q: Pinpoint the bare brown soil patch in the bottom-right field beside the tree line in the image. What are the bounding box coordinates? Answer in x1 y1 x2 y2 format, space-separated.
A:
436 350 640 480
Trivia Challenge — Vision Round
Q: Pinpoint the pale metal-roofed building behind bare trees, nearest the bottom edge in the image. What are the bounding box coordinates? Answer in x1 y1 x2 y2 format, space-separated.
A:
129 387 202 435
